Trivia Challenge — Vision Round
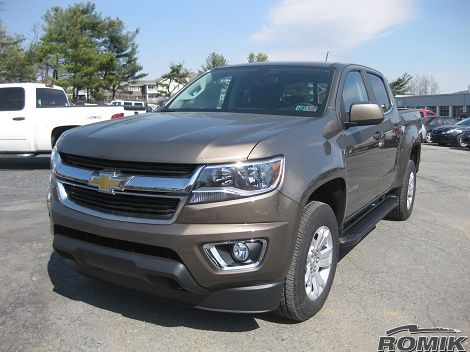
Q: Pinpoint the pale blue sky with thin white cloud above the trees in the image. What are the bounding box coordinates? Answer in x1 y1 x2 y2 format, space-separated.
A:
0 0 470 93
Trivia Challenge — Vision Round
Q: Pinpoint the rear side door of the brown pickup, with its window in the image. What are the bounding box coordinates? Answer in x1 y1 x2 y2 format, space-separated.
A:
366 72 402 195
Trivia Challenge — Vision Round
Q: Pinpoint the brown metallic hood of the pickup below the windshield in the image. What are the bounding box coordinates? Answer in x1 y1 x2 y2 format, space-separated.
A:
58 112 309 164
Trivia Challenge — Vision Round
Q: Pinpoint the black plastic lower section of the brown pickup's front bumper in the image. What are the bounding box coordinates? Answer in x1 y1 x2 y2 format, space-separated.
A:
53 234 283 313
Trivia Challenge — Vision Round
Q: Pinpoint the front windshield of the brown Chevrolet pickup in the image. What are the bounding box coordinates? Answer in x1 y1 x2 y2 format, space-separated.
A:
163 66 333 116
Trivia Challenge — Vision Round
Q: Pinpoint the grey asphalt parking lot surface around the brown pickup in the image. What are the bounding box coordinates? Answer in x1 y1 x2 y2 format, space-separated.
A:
0 145 470 351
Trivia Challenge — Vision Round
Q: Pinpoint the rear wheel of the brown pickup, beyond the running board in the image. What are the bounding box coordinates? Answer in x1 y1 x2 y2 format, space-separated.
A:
386 160 416 221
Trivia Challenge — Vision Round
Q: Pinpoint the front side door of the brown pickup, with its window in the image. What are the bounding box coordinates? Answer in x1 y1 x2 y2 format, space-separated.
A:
340 70 382 217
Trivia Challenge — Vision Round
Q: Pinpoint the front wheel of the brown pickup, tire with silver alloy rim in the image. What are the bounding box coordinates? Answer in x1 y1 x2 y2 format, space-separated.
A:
276 202 339 321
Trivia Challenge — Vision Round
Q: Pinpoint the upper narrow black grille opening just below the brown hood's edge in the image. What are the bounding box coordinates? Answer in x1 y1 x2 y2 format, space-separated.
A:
60 153 197 177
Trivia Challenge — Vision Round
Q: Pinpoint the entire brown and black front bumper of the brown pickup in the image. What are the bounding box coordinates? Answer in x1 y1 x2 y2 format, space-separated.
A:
49 187 298 312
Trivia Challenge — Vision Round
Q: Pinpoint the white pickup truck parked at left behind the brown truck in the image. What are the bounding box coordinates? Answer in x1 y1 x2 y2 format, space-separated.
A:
0 83 140 154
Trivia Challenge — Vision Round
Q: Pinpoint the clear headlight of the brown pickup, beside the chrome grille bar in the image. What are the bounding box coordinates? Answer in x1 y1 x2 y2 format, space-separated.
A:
189 156 284 204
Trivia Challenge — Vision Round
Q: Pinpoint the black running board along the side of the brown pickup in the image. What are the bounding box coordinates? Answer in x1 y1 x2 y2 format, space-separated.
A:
339 196 398 247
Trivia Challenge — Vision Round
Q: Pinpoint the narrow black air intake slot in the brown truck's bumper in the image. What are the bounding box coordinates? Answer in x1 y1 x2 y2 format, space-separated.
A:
54 225 182 262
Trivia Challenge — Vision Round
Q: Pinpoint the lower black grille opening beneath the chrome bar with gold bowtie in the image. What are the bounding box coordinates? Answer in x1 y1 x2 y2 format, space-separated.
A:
63 183 179 220
